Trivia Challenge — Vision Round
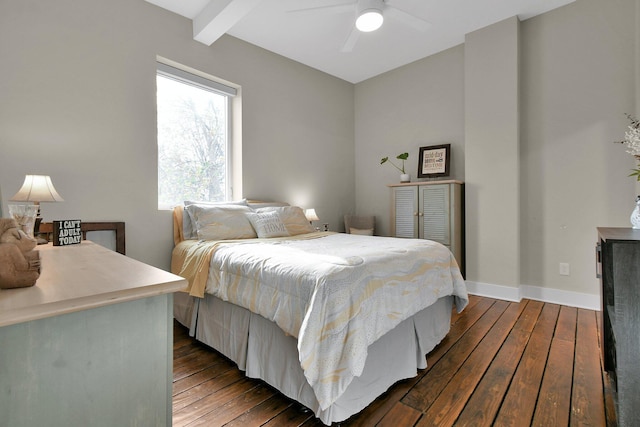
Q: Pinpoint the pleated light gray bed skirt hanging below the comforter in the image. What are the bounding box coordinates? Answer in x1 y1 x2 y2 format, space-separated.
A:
174 293 453 425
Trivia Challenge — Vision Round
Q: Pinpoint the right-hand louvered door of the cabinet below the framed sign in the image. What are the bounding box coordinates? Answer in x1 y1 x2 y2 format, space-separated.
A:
418 184 451 247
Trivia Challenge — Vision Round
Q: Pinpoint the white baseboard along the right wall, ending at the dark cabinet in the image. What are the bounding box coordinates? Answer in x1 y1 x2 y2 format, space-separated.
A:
466 280 600 311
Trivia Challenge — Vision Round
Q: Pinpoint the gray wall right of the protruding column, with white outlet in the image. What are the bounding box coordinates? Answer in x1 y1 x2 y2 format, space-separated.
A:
521 0 640 300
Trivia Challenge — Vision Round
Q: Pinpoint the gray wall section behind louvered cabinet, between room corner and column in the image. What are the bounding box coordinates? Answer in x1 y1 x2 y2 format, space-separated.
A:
355 45 465 235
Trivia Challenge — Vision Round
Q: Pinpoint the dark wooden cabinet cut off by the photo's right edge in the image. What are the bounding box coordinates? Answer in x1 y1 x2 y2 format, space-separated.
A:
597 228 640 426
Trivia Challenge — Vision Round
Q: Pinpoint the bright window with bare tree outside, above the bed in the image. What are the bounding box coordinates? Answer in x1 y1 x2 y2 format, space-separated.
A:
156 63 236 209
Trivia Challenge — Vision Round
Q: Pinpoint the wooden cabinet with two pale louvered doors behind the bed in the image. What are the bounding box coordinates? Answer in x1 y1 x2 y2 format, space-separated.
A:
389 181 464 274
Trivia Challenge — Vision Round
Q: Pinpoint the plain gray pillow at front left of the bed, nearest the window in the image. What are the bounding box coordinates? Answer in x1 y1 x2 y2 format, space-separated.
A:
185 205 257 240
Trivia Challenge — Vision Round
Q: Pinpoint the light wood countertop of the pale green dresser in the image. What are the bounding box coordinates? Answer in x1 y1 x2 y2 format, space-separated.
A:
0 240 187 327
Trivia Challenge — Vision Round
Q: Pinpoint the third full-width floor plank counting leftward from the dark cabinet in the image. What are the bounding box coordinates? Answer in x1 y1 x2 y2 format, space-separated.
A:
495 304 560 426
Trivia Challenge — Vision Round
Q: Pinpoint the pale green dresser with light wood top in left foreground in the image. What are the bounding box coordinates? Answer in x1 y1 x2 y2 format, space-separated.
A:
0 241 187 427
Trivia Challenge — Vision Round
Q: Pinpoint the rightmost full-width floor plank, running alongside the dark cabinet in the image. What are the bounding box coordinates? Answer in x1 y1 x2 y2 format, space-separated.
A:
570 309 606 426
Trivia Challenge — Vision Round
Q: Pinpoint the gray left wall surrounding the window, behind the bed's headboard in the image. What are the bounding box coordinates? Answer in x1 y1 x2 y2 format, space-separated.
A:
0 0 355 268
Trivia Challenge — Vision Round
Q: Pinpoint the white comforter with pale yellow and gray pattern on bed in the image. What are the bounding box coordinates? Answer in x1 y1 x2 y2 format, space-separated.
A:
198 233 468 409
